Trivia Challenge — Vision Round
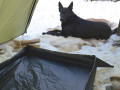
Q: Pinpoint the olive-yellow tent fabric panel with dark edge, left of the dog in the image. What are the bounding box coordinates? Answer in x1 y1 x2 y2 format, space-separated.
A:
0 0 38 44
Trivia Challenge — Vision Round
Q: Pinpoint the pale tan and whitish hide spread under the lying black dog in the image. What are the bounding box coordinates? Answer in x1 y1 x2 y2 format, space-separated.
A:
41 18 117 52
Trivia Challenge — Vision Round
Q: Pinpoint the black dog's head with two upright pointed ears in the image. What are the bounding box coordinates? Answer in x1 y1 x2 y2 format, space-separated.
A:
59 2 73 22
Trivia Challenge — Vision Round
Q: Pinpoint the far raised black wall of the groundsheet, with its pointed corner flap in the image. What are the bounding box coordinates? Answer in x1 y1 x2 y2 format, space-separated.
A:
26 45 113 67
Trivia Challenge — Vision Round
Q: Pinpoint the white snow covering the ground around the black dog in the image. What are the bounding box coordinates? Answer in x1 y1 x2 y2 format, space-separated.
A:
0 0 120 90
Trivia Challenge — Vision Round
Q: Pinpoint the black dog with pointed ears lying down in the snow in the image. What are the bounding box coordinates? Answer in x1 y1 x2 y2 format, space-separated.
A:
43 2 117 39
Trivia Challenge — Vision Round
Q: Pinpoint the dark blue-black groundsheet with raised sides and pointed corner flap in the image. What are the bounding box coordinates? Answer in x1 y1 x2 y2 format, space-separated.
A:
0 46 112 90
